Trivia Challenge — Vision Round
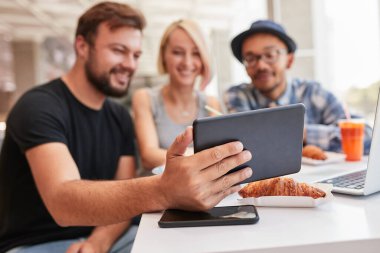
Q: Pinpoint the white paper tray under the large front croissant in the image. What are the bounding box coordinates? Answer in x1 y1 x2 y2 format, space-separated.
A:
238 184 333 207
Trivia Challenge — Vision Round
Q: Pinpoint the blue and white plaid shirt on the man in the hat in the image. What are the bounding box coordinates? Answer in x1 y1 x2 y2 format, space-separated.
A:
224 79 372 154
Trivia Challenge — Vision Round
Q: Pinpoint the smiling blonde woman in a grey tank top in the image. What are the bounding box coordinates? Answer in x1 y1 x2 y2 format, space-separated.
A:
132 20 220 169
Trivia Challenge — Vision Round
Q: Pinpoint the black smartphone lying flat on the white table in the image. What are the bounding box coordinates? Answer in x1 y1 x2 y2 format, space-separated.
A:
158 205 259 228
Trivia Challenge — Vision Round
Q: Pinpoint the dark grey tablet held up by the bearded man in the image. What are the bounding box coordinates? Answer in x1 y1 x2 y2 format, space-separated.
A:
193 104 305 183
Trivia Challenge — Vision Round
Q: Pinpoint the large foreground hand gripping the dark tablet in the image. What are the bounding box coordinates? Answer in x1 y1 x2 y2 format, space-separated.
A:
160 127 252 210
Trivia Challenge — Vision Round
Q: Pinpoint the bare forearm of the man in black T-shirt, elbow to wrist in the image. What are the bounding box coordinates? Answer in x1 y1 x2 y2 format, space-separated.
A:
49 176 166 226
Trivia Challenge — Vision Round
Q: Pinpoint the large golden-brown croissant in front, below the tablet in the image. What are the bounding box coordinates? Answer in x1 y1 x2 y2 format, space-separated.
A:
239 177 326 199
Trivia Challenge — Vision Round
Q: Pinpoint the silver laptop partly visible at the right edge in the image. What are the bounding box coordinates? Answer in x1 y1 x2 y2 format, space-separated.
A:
320 89 380 195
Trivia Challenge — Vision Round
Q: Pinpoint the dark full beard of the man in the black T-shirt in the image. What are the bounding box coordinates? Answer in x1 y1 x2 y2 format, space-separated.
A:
84 57 132 98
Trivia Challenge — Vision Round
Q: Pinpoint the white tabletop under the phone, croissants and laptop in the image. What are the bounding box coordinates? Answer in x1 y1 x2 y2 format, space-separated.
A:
132 161 380 253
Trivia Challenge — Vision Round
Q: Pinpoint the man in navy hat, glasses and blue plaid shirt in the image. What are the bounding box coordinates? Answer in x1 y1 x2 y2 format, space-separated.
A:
224 20 371 153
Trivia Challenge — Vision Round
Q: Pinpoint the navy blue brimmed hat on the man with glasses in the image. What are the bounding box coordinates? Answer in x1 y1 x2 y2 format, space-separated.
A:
231 20 297 62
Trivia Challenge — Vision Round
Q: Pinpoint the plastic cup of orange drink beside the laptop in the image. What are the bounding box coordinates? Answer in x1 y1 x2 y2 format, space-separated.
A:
339 119 364 161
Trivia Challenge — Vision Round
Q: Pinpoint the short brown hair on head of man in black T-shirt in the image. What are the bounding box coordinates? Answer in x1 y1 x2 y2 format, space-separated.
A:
75 2 146 45
